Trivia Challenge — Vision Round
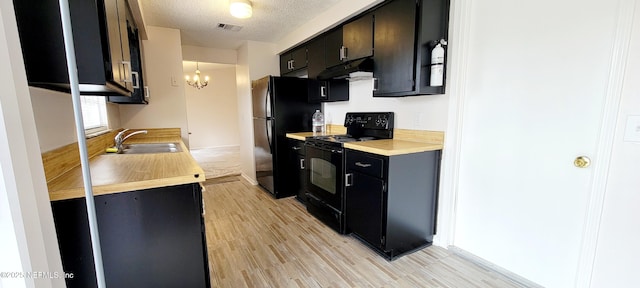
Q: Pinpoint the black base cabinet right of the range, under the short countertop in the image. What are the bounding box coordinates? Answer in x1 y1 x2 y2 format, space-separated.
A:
345 149 441 260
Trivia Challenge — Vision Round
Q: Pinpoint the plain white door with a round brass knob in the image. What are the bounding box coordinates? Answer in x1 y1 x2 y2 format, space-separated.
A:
452 0 619 287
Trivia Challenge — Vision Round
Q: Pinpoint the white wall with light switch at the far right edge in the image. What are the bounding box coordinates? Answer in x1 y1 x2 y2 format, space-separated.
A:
591 2 640 288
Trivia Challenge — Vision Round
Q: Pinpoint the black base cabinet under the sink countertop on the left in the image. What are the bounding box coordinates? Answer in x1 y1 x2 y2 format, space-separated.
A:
52 183 211 288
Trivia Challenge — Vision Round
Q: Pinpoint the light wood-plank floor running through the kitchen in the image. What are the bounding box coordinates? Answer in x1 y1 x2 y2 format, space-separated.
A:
203 176 524 287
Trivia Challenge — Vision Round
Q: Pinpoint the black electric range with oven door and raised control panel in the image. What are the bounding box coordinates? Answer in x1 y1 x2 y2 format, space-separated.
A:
305 112 393 234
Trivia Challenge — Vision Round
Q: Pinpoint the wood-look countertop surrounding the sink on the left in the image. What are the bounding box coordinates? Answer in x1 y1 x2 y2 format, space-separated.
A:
48 135 206 201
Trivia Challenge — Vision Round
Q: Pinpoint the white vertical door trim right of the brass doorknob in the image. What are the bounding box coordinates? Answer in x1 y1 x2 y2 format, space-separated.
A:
575 0 635 287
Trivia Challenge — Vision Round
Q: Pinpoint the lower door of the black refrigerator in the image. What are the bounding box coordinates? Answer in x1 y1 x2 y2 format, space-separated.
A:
253 118 275 194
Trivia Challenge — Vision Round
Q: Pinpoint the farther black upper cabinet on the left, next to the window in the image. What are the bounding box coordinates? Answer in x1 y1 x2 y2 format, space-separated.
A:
108 14 149 104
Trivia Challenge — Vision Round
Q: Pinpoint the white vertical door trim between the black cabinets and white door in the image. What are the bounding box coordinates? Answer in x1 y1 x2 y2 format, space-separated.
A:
434 0 472 247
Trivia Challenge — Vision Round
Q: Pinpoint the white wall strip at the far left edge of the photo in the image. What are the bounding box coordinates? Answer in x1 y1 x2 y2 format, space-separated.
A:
0 1 65 287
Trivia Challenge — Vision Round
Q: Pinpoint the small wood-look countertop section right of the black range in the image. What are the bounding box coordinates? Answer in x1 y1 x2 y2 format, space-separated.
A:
344 139 443 156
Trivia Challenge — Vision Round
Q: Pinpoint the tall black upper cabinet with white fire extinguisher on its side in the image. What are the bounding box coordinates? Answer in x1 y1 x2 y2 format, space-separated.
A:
373 0 449 97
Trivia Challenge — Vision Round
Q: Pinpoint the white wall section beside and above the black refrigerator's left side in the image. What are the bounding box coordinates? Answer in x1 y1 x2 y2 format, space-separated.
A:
236 41 280 184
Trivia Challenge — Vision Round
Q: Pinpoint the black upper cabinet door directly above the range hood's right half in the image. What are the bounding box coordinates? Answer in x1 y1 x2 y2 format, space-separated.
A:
340 13 373 62
